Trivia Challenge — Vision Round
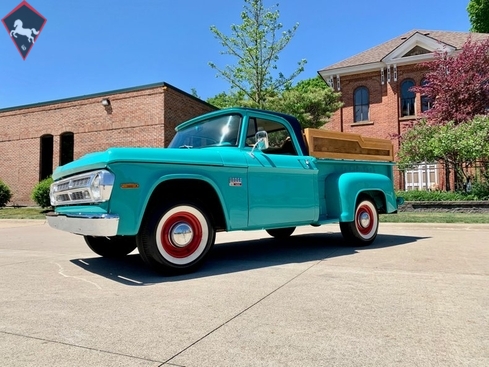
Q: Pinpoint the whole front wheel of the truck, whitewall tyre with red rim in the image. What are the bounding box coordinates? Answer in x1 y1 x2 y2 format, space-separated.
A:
137 203 216 275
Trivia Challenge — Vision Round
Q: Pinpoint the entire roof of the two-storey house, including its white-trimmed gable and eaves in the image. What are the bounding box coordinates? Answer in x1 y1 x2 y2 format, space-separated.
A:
318 29 489 78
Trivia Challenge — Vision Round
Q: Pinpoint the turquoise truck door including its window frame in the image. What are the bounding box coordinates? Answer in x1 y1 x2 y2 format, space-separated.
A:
245 117 319 228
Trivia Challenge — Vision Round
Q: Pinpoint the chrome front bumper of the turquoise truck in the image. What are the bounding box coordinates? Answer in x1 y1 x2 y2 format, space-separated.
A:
46 212 119 237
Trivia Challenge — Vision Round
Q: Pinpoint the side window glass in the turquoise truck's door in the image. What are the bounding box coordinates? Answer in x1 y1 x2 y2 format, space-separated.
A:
246 117 297 155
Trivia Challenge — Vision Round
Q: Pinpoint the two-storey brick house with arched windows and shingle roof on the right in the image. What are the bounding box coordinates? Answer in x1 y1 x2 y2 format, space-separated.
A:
318 30 489 189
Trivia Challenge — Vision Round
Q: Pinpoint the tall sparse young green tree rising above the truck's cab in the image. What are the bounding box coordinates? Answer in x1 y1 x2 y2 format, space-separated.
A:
209 0 306 108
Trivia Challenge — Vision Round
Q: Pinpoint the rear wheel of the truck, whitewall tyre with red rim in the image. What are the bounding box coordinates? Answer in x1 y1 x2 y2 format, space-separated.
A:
340 199 379 246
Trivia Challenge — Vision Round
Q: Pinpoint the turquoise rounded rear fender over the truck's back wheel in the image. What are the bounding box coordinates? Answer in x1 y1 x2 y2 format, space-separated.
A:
325 172 397 222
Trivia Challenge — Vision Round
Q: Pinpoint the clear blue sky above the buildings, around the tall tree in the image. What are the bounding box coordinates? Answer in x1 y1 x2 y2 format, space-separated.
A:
0 0 470 109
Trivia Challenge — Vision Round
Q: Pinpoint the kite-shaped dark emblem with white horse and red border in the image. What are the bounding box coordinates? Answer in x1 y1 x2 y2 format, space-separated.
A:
2 0 46 60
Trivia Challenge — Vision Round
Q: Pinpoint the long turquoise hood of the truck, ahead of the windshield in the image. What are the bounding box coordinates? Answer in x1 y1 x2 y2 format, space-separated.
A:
53 148 223 180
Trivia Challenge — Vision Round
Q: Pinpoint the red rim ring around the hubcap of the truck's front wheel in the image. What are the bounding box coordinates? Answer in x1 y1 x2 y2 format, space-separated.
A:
160 212 202 259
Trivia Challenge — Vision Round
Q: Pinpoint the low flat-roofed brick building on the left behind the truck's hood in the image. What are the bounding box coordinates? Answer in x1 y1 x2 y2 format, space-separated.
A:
0 83 216 205
